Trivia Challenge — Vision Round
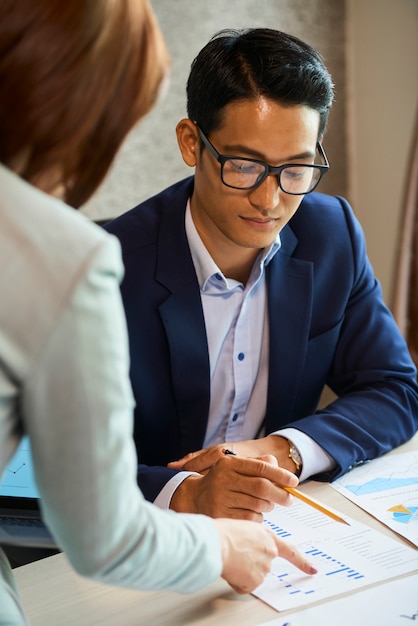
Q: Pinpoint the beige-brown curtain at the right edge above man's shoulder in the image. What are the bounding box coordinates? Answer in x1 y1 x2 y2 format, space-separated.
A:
393 112 418 366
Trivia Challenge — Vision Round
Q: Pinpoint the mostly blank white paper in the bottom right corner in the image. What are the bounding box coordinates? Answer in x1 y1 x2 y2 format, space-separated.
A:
262 575 418 626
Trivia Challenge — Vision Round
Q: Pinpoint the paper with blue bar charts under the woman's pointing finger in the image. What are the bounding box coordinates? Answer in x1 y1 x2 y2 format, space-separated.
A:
253 500 418 611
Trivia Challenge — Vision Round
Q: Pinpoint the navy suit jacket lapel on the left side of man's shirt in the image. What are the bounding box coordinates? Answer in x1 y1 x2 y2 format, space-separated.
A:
156 178 210 454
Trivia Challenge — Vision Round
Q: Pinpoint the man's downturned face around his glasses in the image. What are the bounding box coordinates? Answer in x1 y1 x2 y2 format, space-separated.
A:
177 98 319 269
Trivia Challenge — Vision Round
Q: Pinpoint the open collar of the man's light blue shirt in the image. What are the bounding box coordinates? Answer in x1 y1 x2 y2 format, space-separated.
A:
185 199 281 291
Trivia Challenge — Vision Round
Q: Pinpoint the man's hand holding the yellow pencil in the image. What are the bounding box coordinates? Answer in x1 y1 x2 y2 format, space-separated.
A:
170 446 298 522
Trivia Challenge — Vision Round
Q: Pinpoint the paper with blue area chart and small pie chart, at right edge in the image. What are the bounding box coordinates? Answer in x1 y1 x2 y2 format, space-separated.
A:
331 452 418 547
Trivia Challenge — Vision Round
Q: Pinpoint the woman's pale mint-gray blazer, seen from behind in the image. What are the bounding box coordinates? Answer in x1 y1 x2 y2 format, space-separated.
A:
0 166 221 624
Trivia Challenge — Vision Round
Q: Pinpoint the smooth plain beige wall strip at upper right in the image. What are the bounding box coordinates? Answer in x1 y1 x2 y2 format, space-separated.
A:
346 0 418 305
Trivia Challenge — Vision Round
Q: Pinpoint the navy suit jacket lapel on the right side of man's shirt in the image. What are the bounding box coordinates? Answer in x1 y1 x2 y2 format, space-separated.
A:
266 226 313 432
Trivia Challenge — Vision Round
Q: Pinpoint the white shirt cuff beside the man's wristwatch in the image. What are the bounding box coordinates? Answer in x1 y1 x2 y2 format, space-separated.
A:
270 428 336 482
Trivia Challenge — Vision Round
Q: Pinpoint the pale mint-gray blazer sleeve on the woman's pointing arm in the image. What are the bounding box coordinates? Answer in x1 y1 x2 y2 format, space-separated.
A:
22 236 221 592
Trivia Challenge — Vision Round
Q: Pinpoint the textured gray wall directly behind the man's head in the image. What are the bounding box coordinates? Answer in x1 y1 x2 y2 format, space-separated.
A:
84 0 348 219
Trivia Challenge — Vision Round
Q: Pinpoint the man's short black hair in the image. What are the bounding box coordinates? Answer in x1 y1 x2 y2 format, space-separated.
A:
187 28 333 137
